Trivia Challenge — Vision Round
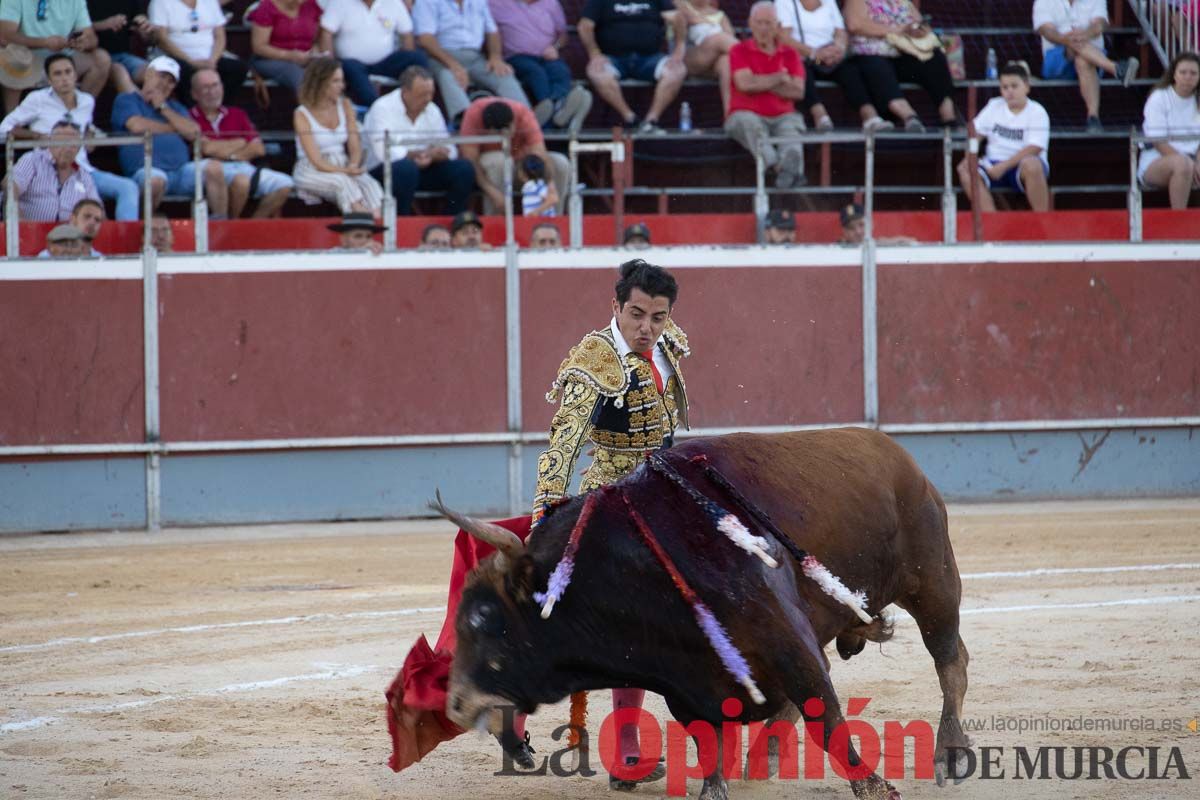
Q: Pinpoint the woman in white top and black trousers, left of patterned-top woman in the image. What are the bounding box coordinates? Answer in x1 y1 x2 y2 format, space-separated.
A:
775 0 894 132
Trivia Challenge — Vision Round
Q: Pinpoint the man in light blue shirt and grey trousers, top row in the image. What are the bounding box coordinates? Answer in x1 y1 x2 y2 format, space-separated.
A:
414 0 529 125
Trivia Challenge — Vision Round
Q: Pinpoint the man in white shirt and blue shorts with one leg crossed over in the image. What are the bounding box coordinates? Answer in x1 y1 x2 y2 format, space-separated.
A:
1033 0 1138 132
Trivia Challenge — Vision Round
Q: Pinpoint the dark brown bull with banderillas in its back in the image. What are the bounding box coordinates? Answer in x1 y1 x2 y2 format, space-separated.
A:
438 428 968 800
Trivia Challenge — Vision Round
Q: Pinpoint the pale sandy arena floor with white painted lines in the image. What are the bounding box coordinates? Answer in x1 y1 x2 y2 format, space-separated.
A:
0 500 1200 800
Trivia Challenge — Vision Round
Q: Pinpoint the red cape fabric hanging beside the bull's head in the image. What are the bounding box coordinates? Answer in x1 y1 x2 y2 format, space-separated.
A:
385 517 533 772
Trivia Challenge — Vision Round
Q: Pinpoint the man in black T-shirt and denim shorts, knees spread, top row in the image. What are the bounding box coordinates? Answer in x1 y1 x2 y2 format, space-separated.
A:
577 0 688 133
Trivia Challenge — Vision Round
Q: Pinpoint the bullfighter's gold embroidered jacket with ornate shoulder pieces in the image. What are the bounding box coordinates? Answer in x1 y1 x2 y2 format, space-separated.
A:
533 320 690 522
